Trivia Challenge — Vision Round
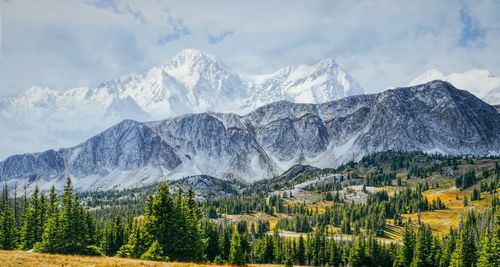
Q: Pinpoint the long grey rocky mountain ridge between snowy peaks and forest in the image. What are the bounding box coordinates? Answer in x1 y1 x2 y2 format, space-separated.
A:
0 81 500 190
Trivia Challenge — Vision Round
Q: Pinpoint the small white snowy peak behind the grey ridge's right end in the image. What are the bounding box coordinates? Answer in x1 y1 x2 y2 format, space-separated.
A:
409 69 500 105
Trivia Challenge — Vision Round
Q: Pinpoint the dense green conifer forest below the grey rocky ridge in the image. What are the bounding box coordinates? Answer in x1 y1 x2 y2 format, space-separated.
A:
0 152 500 266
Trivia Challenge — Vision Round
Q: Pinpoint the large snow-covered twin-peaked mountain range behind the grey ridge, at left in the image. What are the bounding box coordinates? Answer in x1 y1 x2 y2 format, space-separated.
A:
0 49 363 159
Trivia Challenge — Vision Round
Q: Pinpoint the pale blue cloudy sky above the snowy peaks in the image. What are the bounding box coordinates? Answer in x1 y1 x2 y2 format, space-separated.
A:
0 0 500 96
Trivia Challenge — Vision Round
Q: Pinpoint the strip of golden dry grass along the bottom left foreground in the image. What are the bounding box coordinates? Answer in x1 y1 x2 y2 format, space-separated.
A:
0 250 286 267
